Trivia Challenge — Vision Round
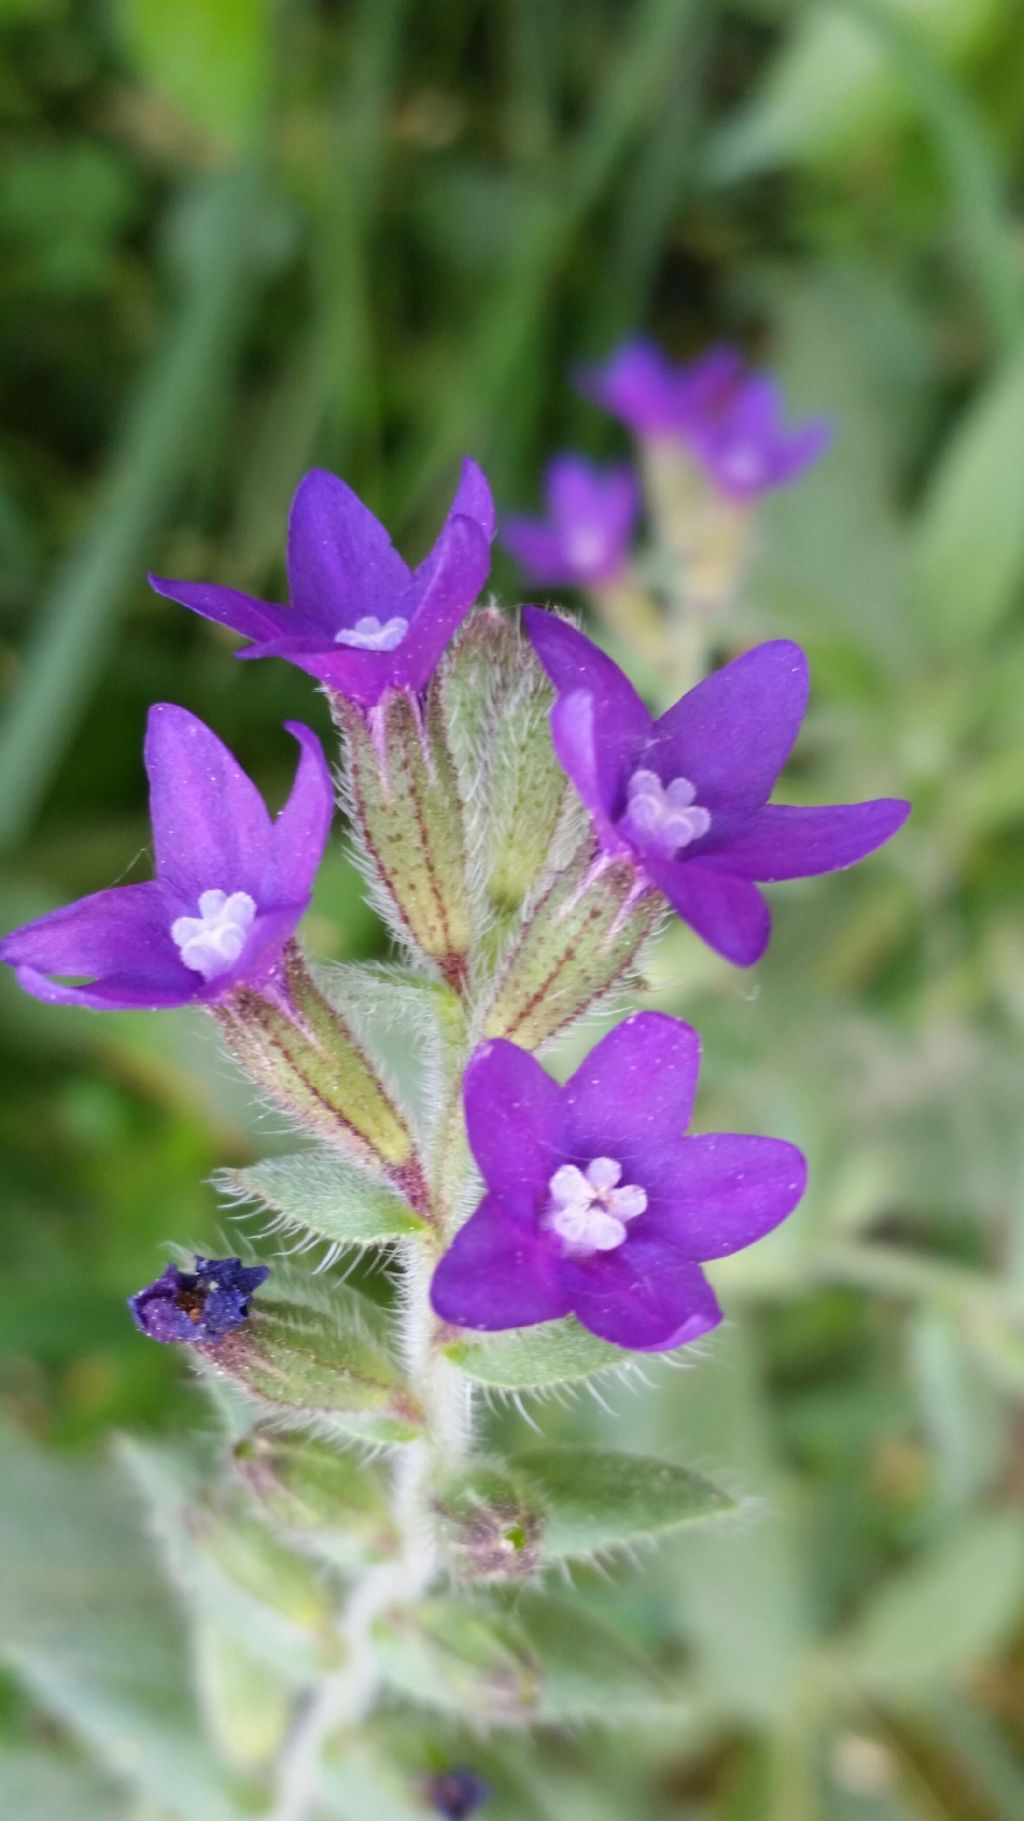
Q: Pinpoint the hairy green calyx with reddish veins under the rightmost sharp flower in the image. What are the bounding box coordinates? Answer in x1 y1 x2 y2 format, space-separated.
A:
481 841 663 1049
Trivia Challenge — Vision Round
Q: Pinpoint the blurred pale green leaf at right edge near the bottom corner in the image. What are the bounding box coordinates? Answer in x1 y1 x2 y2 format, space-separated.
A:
845 1511 1024 1701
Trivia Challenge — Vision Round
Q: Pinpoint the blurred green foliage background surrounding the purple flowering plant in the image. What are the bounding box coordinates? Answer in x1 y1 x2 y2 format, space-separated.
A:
0 0 1024 1821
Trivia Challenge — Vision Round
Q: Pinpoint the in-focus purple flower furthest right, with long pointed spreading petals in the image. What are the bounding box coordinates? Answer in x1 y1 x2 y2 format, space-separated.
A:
525 606 909 967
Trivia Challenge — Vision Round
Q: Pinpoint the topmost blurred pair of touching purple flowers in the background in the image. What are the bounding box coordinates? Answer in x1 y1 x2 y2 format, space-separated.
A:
581 341 833 501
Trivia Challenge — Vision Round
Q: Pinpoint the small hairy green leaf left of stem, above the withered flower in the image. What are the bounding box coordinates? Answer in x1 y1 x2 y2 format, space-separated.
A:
215 1149 425 1246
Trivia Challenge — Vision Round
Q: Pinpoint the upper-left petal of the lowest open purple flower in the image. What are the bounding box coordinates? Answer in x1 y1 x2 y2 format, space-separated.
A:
463 1038 563 1195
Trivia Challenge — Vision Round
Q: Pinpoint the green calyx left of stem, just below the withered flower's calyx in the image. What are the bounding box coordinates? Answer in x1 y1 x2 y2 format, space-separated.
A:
233 1424 397 1568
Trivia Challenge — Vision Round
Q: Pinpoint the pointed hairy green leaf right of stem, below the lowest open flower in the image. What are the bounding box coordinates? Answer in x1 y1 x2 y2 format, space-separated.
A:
512 1448 736 1557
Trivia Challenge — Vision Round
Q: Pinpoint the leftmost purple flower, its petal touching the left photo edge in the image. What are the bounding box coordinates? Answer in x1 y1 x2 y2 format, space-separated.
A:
0 703 333 1011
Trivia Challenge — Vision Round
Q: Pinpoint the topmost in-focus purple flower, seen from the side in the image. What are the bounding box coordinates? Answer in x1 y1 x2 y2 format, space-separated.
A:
149 461 494 708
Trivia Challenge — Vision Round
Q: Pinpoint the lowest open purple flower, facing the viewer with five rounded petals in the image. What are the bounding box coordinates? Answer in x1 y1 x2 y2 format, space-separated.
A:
432 1012 807 1351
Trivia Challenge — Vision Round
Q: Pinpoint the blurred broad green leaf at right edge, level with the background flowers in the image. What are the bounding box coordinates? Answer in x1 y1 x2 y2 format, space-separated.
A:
913 357 1024 646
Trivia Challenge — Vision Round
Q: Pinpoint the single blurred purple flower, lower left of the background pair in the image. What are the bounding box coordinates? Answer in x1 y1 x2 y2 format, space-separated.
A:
501 455 640 588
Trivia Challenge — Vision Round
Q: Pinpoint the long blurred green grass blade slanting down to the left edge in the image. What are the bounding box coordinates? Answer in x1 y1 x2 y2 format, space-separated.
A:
0 164 261 847
